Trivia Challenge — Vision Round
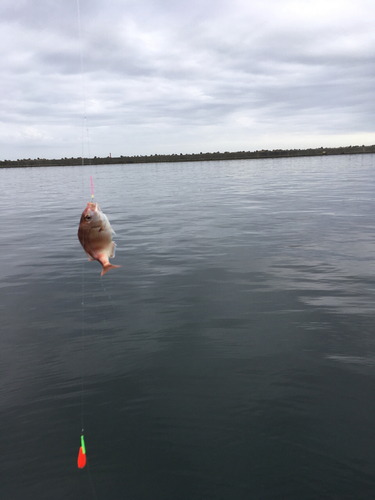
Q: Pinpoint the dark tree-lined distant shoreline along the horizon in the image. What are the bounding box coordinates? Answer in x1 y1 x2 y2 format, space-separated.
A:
0 145 375 168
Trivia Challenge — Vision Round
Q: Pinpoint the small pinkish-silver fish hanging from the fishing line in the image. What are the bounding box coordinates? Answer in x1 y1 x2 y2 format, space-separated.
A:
78 202 121 276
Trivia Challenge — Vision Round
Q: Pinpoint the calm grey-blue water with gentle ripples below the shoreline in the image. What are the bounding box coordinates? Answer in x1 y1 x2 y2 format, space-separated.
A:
0 155 375 500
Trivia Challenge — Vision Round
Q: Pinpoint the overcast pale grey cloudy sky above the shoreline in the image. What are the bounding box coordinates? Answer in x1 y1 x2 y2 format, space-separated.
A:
0 0 375 160
